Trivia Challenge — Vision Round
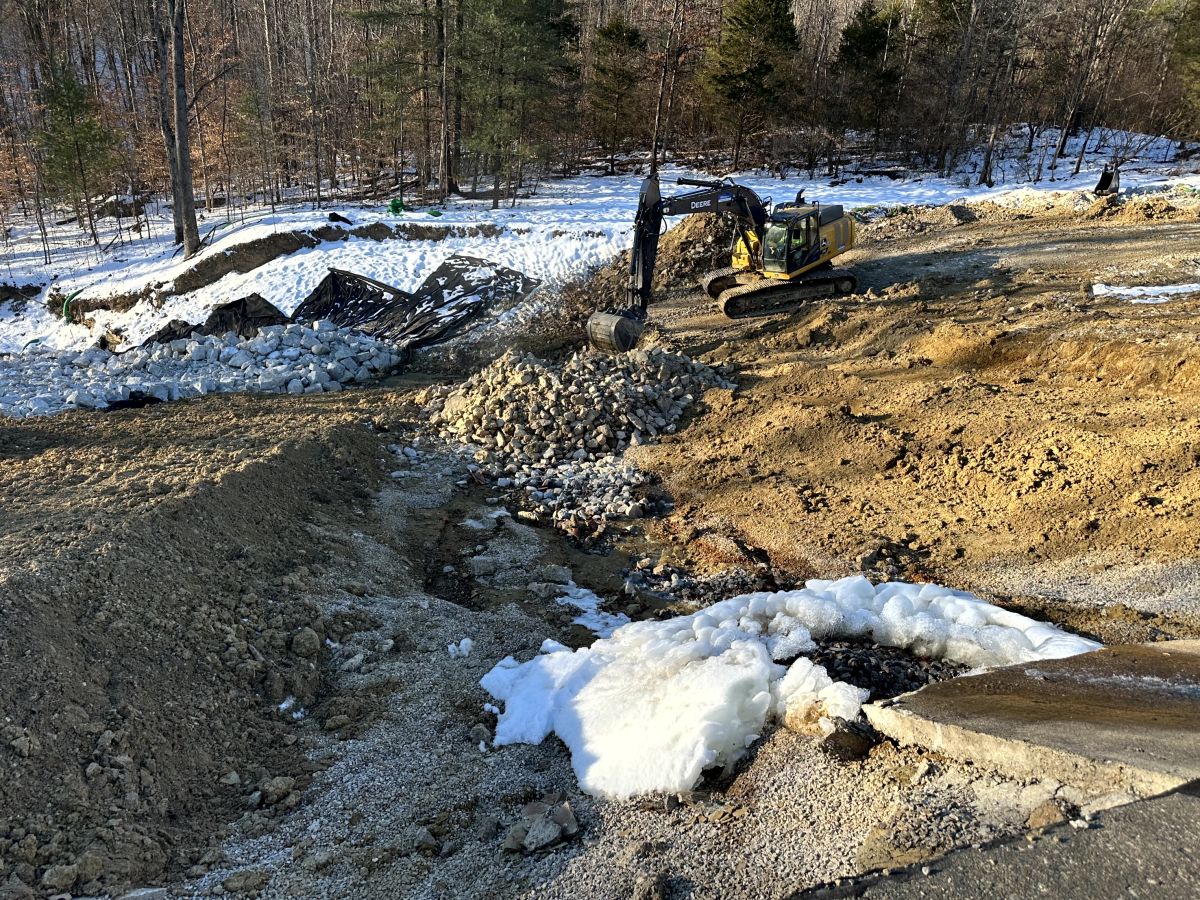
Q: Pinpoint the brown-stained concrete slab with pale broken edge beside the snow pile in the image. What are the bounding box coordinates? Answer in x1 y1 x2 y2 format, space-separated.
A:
864 641 1200 797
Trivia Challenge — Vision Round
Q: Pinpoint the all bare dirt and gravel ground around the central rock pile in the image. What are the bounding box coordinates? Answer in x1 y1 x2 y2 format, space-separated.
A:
0 188 1200 900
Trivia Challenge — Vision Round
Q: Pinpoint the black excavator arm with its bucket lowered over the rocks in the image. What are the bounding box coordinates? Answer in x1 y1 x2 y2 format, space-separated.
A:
588 173 768 353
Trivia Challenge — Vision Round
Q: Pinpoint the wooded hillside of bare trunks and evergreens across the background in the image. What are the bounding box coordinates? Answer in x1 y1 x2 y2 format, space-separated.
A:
0 0 1200 259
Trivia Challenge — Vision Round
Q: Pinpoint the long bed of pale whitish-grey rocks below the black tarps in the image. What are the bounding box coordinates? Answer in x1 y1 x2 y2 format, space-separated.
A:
0 320 401 419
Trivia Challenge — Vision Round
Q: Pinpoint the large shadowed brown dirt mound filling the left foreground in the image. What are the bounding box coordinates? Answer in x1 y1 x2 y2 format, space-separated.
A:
0 395 398 894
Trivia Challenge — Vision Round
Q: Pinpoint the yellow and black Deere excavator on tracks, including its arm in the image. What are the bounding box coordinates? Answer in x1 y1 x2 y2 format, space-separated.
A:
587 174 858 353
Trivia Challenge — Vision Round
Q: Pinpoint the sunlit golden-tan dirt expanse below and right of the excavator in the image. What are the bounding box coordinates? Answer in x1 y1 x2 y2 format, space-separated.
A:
632 200 1200 638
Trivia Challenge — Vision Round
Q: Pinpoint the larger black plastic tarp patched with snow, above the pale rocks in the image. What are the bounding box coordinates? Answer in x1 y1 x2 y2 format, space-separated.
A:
292 256 540 349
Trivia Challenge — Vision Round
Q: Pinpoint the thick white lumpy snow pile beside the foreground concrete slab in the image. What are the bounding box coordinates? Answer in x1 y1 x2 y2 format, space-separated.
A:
481 576 1099 797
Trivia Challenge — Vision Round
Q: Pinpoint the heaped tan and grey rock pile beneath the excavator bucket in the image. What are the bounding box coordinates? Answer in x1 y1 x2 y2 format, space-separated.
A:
425 348 733 528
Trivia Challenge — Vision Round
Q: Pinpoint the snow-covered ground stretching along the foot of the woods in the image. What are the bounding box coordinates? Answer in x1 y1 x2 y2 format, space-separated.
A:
0 132 1200 353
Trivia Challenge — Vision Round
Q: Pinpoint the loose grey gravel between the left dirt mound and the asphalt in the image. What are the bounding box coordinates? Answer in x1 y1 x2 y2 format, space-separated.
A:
178 445 1052 899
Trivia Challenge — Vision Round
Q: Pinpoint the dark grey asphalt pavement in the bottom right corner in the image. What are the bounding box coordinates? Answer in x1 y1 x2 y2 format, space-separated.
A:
794 790 1200 900
